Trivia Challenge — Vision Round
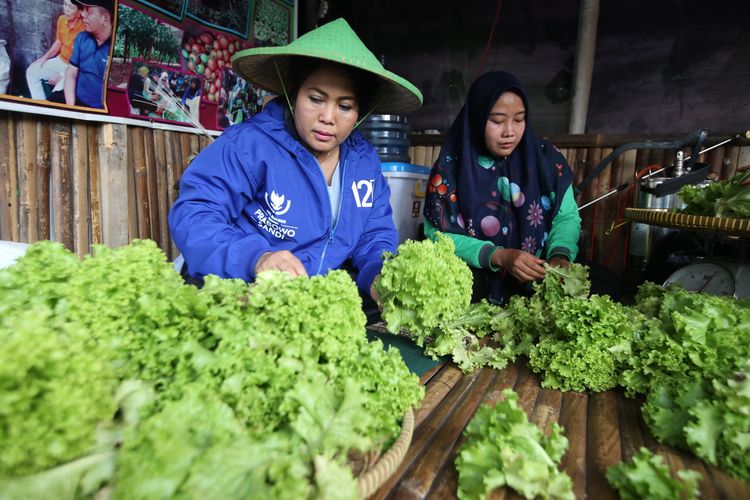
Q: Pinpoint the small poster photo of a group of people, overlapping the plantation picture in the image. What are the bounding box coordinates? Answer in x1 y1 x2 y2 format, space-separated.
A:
127 61 202 123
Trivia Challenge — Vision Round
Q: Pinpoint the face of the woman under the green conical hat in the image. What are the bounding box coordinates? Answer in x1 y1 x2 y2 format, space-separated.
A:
294 64 359 158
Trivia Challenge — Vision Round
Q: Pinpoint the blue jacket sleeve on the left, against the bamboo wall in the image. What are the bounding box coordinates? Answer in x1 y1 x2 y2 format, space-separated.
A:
169 134 270 281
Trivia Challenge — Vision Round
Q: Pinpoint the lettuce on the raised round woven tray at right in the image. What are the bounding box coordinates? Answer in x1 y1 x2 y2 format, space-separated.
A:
677 170 750 219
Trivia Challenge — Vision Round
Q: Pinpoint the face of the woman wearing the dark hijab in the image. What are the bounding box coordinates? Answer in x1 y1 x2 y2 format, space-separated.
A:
484 91 526 157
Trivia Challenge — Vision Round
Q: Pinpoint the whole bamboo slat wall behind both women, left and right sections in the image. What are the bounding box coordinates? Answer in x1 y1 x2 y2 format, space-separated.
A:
0 112 750 271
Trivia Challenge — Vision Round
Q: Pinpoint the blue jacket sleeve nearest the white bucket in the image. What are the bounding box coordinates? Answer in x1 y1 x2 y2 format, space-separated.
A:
352 160 398 293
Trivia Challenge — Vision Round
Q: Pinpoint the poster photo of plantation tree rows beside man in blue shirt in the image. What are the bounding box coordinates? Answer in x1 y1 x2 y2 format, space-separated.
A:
108 3 183 91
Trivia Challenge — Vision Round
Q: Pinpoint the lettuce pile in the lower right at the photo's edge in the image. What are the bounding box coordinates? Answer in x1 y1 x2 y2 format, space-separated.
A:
622 283 750 481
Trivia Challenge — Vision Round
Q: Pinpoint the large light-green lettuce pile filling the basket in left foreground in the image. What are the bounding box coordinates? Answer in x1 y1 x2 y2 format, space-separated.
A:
0 241 424 499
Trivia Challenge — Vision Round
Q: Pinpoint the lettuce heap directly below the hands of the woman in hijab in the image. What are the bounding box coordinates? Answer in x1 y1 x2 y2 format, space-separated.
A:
494 263 644 392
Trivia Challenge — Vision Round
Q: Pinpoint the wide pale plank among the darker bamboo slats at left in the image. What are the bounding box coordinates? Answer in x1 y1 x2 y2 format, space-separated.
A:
97 123 132 247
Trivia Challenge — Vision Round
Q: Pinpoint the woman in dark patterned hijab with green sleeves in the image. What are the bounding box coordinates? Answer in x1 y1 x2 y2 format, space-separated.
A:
424 71 581 304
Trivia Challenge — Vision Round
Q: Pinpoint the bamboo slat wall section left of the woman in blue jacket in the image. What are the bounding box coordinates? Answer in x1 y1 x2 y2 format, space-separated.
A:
0 112 208 259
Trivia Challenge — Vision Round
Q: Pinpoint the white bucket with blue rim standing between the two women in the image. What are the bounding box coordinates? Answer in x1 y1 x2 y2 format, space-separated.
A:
380 162 430 244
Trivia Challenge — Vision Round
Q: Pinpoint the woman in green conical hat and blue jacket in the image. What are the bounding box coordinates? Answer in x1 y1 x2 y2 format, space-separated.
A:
169 19 422 300
